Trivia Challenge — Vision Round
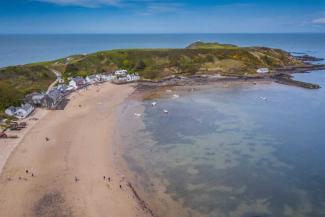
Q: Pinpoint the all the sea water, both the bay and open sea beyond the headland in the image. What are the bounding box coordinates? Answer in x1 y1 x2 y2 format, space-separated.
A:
0 33 325 217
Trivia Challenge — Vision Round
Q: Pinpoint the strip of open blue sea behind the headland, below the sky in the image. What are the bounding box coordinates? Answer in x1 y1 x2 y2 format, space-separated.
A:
0 33 325 67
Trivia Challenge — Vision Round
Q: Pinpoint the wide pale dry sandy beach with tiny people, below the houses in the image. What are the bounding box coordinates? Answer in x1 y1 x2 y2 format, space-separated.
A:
0 83 151 217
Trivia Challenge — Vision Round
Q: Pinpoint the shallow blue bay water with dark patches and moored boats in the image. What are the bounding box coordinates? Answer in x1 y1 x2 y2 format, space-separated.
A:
118 71 325 217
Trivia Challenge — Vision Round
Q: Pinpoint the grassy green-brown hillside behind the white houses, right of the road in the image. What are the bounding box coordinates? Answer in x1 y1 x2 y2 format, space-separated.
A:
56 42 302 80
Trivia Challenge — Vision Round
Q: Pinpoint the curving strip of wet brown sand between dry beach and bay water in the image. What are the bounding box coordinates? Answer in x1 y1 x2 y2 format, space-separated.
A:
114 87 208 217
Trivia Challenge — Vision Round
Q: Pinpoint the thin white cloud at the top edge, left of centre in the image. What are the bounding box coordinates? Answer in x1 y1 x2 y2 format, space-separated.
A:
36 0 120 7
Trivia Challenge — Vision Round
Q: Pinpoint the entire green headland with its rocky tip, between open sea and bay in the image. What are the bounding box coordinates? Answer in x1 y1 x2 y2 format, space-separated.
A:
0 41 324 116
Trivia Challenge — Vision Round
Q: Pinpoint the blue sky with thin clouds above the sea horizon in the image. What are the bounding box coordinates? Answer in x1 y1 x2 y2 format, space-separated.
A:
0 0 325 34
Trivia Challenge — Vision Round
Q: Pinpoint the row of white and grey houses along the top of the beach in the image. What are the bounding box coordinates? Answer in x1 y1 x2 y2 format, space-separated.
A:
0 70 140 138
